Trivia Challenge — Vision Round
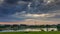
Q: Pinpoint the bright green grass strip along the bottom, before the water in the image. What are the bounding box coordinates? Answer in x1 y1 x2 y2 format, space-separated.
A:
0 32 60 34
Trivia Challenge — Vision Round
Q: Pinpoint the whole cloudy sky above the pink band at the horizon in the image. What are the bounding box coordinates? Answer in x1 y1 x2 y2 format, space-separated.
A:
0 0 60 23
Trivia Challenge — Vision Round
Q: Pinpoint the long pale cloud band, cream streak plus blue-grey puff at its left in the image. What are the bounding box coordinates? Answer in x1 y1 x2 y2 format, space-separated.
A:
14 11 56 18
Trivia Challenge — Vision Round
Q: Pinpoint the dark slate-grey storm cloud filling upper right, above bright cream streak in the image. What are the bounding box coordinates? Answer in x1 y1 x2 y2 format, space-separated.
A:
25 1 60 14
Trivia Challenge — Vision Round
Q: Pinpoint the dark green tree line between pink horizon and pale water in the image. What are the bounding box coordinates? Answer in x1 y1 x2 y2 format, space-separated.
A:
0 24 60 31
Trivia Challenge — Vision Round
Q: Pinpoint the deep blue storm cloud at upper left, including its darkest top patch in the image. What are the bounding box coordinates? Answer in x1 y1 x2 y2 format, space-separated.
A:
0 0 27 17
